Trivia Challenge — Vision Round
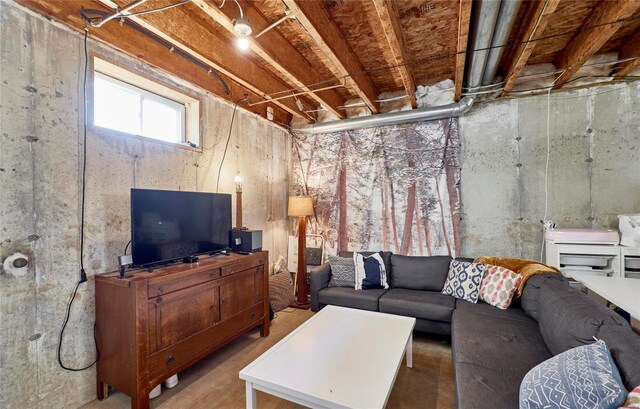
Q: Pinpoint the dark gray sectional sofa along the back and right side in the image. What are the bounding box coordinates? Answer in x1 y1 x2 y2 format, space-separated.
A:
311 253 640 409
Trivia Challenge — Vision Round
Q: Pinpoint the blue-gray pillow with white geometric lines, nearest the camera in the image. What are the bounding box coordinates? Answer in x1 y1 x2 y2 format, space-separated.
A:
520 340 627 409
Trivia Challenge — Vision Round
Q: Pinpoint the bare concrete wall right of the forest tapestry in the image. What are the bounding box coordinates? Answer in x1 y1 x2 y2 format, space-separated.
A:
460 82 640 259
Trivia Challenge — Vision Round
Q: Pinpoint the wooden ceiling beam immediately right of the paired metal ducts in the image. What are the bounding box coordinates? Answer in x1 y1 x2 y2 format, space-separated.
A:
501 0 560 97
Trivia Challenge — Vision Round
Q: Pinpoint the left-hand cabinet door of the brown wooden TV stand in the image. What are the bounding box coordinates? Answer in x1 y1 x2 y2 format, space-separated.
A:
148 282 220 352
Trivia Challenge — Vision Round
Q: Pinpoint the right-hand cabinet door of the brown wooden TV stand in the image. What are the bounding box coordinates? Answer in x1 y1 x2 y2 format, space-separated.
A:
220 266 263 321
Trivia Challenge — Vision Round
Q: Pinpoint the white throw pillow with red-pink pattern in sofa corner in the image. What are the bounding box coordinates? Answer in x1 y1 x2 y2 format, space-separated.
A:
480 264 522 310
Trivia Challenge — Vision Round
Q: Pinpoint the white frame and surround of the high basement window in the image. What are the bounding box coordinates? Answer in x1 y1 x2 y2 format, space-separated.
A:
87 54 203 152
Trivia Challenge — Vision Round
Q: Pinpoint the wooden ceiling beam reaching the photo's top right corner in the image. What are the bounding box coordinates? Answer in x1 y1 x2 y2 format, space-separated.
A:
554 0 640 89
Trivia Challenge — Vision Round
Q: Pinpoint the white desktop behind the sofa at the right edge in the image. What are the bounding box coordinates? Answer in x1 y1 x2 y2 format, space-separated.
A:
572 273 640 320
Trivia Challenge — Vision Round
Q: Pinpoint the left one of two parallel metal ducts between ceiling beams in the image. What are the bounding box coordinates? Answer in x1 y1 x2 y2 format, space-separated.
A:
467 0 502 89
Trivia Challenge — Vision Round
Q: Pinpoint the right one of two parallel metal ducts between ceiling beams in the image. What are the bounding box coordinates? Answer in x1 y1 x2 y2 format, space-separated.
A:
482 0 522 85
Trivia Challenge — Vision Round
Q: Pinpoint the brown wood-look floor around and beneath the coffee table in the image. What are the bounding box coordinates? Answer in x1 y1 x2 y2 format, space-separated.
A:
84 309 455 409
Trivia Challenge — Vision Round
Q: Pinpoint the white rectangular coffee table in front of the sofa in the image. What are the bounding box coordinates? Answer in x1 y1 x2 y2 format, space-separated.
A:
240 306 416 409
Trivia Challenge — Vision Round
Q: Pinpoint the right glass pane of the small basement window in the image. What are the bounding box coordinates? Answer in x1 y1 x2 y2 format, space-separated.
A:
142 98 182 142
